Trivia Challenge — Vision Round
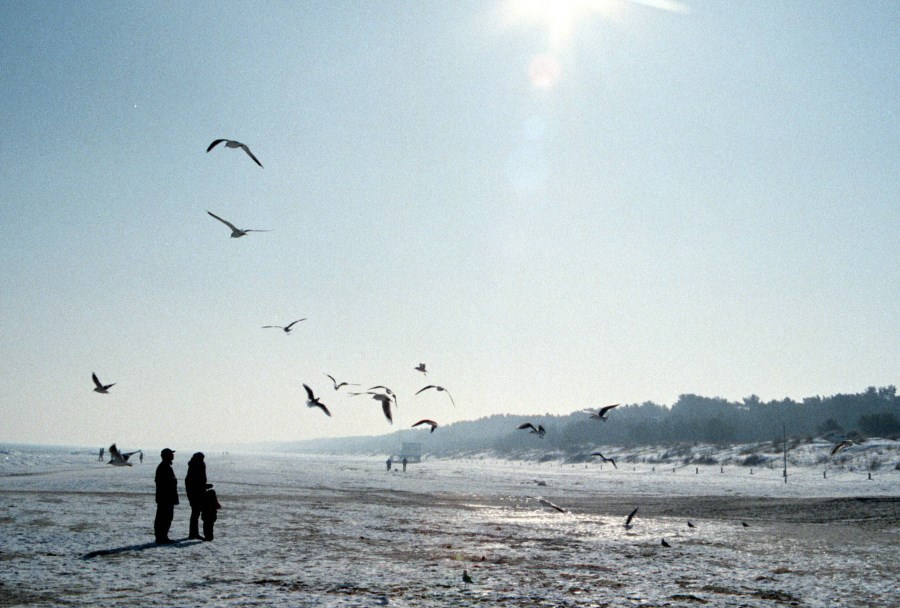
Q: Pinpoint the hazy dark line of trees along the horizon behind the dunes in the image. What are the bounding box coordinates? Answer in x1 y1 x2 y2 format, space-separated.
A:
279 386 900 456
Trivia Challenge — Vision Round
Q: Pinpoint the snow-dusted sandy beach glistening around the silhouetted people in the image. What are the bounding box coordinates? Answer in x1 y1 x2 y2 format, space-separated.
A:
0 442 900 607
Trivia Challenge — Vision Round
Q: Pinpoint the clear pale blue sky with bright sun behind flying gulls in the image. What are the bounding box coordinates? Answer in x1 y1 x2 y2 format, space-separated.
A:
0 0 900 450
